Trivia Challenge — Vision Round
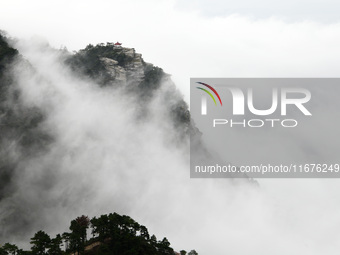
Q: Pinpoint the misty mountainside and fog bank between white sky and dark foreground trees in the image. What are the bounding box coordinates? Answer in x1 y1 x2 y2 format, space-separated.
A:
0 31 340 255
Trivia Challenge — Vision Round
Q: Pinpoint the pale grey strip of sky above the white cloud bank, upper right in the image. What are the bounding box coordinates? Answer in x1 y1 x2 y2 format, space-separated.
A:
176 0 340 23
